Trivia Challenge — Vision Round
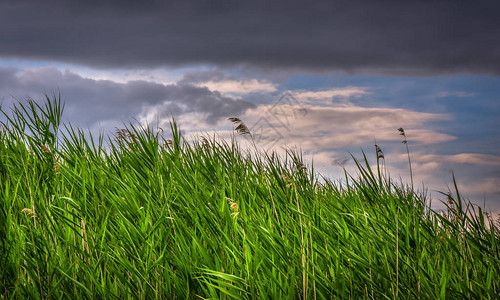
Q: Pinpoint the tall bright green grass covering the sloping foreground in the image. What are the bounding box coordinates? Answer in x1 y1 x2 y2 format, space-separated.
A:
0 96 500 299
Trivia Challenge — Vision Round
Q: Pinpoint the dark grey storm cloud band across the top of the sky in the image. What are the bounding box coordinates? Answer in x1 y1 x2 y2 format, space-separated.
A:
0 0 500 75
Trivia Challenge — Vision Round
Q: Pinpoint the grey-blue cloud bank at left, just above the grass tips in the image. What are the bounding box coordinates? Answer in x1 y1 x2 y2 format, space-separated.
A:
0 67 254 126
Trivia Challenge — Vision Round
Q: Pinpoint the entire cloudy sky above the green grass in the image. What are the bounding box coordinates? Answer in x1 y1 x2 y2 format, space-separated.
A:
0 0 500 215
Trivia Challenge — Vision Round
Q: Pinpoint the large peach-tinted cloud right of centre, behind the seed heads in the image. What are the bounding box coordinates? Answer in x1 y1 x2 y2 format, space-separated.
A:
238 105 455 155
